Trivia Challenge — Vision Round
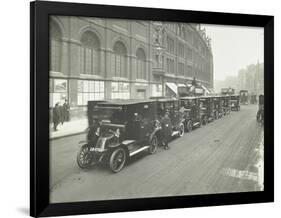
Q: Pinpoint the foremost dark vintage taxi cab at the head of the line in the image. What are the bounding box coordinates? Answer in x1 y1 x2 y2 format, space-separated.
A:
77 100 161 173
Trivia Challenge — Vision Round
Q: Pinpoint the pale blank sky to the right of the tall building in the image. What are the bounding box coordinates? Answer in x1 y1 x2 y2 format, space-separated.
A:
202 24 264 80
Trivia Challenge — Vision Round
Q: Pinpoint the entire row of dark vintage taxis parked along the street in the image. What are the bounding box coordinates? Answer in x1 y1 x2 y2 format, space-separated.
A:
77 95 240 173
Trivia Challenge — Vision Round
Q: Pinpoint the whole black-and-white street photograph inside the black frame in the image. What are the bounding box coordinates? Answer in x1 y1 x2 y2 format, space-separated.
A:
49 15 264 203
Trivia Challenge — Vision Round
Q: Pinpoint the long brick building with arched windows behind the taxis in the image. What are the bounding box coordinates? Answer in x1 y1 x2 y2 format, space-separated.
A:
49 16 213 119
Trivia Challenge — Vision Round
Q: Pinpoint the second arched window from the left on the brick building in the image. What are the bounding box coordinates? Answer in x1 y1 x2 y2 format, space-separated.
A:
81 31 100 75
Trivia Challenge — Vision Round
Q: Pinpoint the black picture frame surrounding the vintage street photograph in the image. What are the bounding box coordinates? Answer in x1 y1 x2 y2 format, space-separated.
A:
30 1 274 217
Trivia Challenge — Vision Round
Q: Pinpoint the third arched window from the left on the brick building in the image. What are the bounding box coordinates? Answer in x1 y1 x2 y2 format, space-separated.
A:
112 41 127 77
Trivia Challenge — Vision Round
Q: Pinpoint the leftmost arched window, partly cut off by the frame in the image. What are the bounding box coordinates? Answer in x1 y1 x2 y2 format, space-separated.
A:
49 20 62 72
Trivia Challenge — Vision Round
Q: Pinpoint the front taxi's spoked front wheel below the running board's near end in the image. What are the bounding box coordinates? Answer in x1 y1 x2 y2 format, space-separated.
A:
109 148 126 173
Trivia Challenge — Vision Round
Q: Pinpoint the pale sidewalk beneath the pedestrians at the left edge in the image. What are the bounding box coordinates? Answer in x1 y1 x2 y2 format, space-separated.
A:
49 118 88 139
